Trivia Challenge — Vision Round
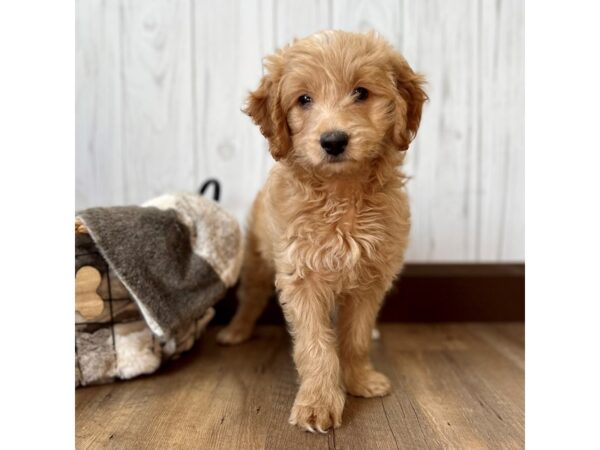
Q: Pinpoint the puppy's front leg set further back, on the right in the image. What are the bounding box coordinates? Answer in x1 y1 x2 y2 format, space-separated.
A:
337 289 391 397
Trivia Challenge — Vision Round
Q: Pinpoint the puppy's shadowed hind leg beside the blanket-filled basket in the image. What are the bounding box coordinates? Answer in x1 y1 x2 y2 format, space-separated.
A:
217 235 274 345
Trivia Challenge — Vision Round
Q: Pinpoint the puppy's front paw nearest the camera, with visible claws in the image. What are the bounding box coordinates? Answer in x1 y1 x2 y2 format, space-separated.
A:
290 387 346 433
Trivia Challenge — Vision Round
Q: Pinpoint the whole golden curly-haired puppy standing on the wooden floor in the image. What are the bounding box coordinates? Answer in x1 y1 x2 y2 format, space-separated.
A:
218 31 427 432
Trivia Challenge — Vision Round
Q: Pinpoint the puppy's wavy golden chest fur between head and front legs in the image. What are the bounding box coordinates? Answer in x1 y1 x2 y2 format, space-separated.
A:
276 176 410 288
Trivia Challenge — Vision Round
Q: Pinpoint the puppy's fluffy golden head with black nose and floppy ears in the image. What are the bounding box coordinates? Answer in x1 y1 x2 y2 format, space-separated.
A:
246 31 427 173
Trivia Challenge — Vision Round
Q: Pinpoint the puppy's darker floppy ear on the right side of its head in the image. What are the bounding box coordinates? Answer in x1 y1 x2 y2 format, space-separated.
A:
392 53 429 150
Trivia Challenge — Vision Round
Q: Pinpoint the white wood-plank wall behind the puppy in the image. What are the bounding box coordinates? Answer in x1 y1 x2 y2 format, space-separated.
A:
76 0 525 261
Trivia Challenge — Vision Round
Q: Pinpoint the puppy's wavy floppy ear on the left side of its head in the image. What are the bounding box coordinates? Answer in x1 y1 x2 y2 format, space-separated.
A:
243 54 292 160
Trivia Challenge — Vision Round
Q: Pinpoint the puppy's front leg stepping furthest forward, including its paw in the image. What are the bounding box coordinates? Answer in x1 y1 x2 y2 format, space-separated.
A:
280 280 346 433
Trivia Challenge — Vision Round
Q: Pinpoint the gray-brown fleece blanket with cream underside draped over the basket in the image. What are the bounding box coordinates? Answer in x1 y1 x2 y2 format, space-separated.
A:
78 194 242 337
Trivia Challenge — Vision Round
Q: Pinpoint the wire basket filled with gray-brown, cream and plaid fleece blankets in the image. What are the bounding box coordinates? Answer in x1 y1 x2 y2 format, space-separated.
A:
76 194 242 385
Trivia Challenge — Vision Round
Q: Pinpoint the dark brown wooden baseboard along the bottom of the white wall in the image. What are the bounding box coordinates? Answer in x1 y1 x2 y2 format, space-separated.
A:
213 264 525 324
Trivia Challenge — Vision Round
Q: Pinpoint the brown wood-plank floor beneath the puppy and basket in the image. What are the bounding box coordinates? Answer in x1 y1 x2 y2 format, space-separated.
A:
76 323 524 450
